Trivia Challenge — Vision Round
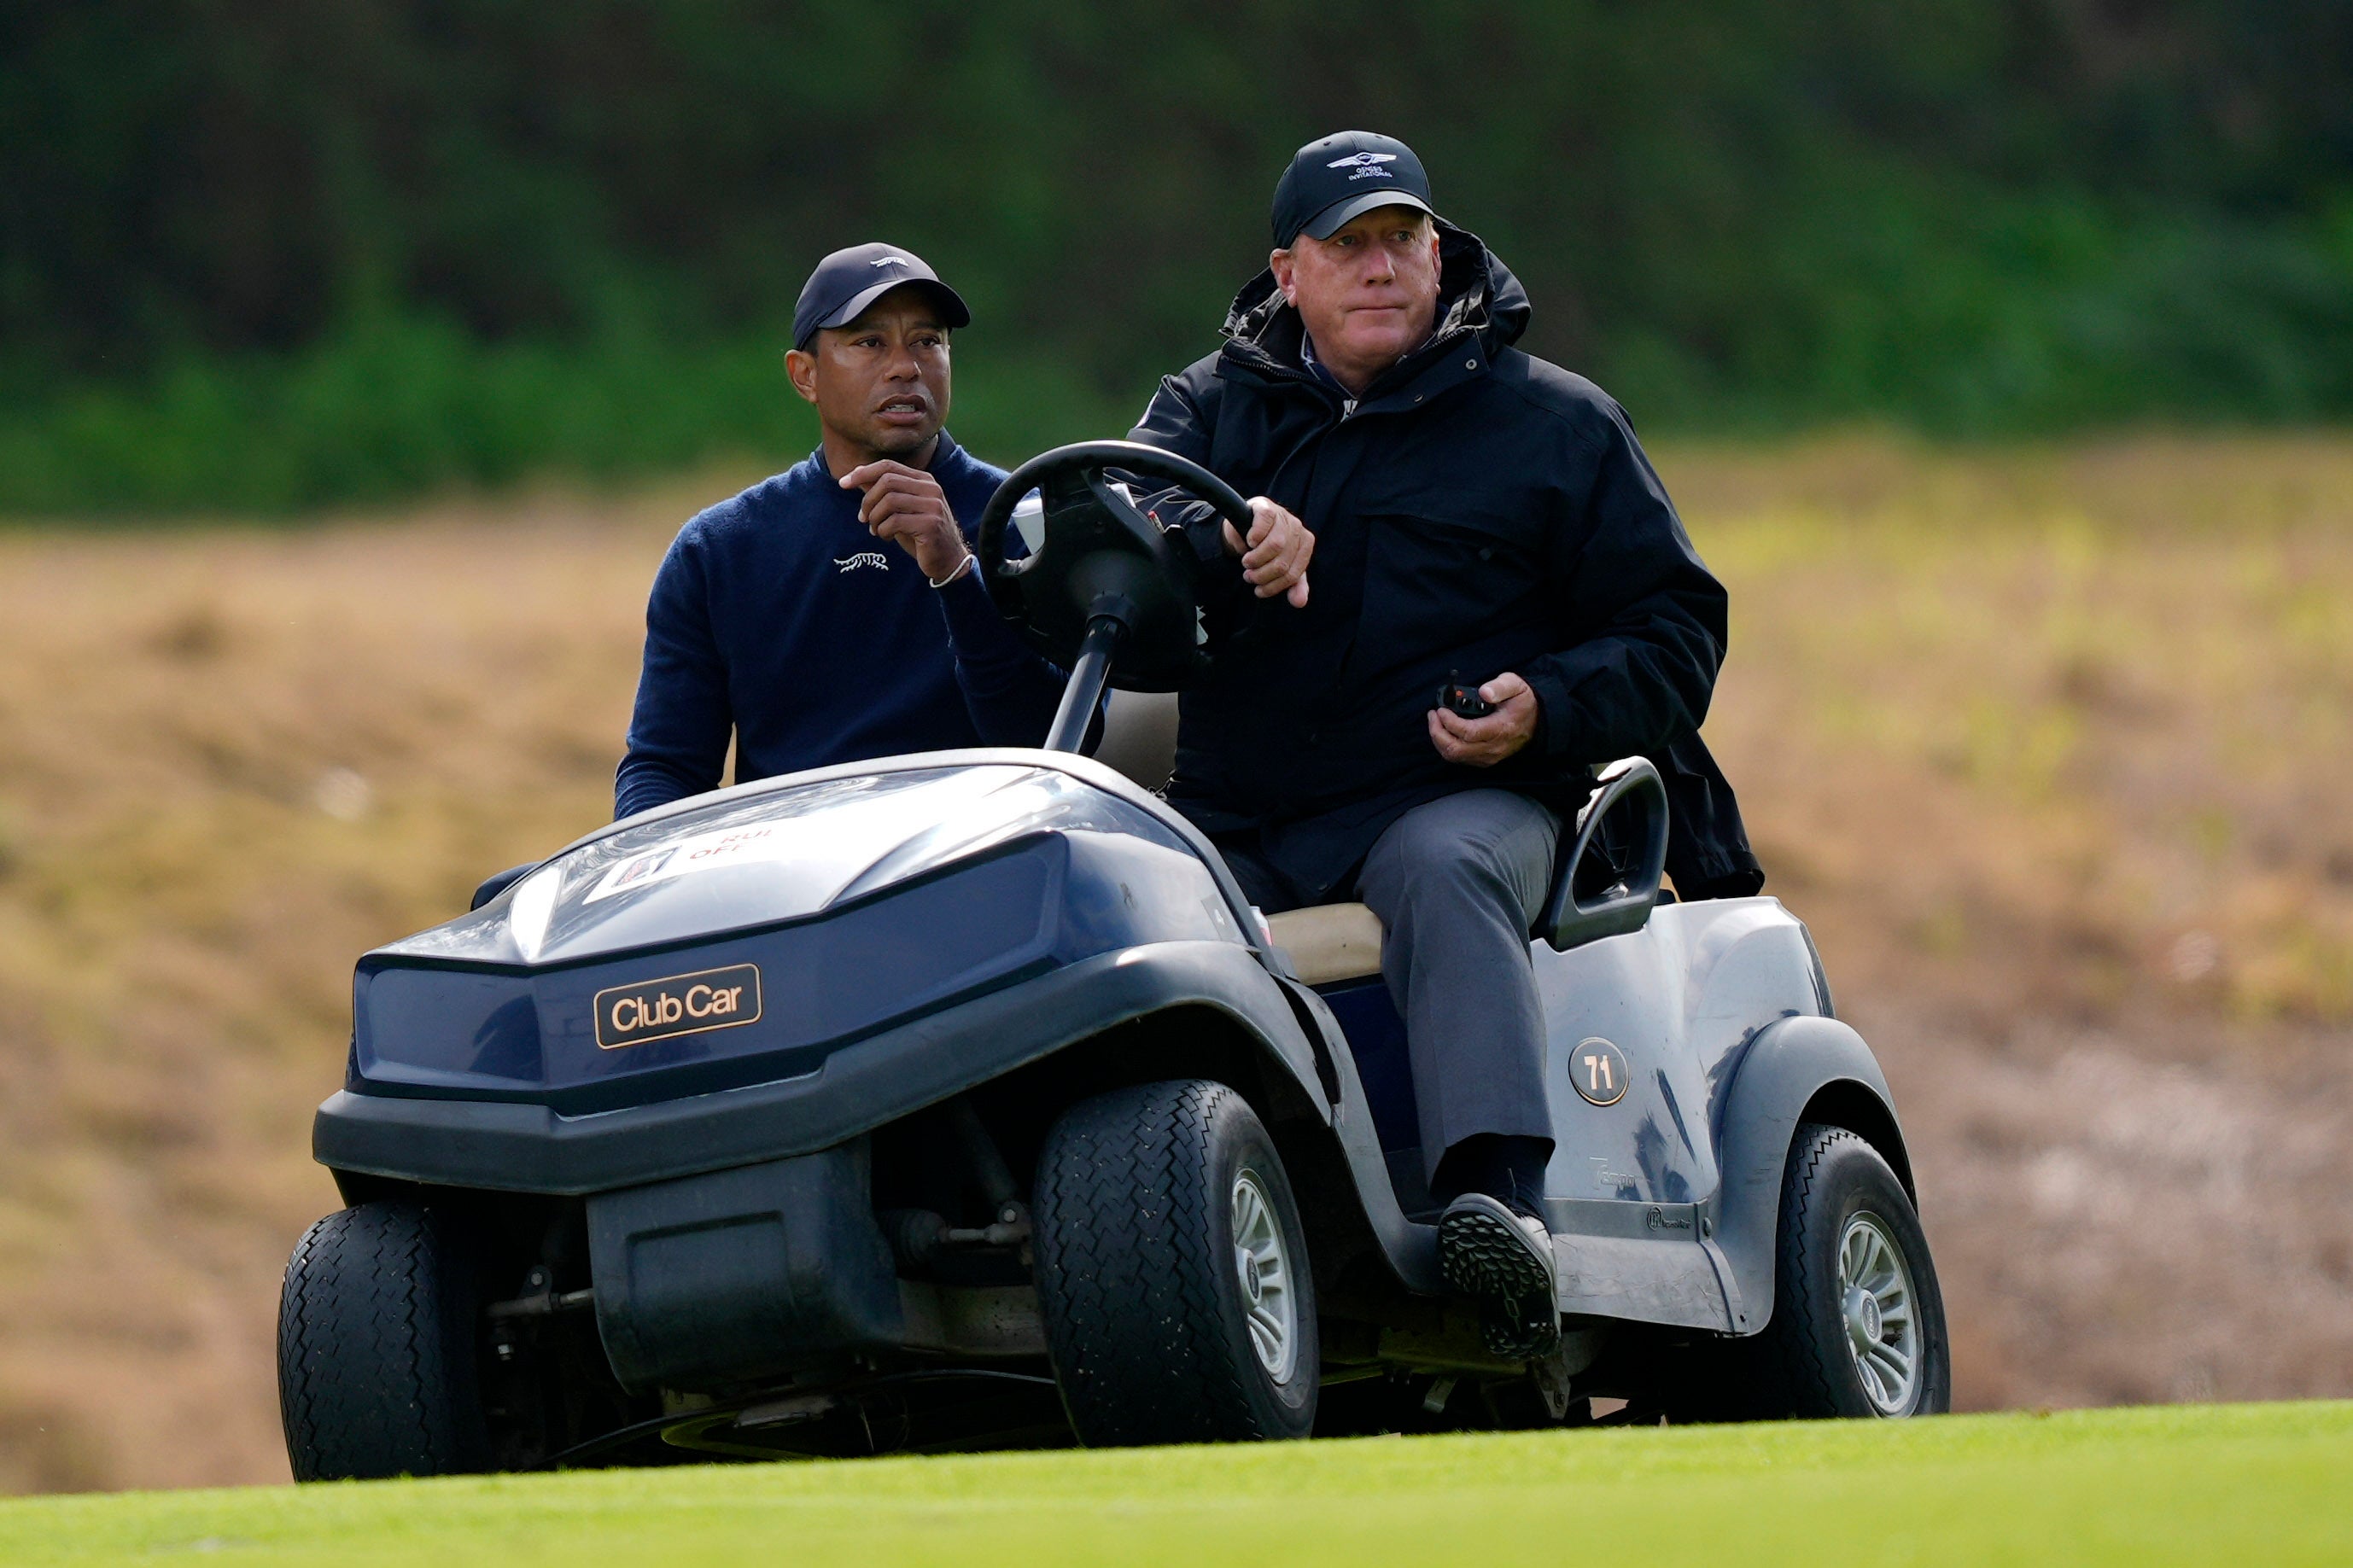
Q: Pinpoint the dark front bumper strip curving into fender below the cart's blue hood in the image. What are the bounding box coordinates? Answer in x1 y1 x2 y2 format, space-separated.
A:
313 942 1329 1194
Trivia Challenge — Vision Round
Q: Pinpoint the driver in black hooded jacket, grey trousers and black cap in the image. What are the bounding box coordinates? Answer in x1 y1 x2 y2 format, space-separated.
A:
1134 131 1762 1356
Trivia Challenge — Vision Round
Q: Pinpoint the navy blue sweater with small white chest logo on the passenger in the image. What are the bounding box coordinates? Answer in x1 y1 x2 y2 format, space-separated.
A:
614 433 1061 816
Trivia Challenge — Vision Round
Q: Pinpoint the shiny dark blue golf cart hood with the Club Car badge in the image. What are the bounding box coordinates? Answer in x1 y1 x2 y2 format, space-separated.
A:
348 752 1247 1114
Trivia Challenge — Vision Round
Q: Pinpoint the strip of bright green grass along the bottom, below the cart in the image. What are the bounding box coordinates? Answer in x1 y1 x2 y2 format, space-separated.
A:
0 1403 2353 1568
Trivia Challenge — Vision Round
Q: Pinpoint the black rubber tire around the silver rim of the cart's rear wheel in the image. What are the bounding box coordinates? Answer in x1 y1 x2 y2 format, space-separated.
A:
1737 1123 1953 1419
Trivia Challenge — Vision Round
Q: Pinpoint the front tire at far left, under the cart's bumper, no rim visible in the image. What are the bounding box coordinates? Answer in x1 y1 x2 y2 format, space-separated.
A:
277 1204 489 1481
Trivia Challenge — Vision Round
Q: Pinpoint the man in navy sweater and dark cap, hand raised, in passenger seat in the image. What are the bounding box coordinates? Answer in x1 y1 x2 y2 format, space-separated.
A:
614 244 1061 816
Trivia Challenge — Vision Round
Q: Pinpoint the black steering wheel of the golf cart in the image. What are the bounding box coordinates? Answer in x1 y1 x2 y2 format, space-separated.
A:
977 442 1249 691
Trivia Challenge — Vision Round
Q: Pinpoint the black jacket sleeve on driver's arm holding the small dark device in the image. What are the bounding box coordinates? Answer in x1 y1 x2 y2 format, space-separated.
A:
1522 405 1727 761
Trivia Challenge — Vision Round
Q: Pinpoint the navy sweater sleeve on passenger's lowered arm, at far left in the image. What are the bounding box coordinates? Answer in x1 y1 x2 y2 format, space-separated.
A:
612 527 734 818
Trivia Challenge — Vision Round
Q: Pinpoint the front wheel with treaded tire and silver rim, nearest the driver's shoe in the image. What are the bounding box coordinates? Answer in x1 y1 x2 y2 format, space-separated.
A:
1033 1079 1320 1446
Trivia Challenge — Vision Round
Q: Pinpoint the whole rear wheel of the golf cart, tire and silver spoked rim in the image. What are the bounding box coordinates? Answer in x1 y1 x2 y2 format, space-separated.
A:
1749 1123 1953 1418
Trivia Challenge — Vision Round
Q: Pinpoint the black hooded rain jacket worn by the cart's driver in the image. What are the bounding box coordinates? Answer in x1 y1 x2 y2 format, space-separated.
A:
1134 224 1762 903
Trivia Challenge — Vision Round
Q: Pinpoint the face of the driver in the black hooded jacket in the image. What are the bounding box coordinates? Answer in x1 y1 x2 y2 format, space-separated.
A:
1273 207 1438 386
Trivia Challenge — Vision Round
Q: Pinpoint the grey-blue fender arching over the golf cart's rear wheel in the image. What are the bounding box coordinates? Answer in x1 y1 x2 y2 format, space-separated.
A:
1715 1018 1911 1333
